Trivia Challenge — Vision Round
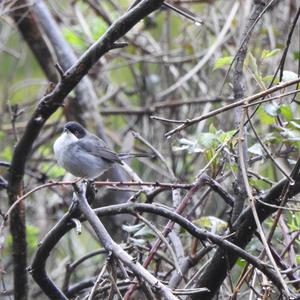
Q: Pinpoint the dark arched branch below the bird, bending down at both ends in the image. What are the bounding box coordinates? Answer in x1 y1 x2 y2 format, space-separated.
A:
31 197 284 299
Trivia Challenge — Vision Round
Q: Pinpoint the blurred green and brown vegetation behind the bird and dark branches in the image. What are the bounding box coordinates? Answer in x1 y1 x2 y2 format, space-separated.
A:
0 0 300 299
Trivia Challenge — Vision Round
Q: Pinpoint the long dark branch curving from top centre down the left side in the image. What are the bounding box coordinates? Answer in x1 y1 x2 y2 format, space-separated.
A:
8 0 163 299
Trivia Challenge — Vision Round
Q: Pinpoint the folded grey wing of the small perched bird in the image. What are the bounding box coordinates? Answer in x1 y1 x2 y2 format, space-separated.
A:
76 134 122 164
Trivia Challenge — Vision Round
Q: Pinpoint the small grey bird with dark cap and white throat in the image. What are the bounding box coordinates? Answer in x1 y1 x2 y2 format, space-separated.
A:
53 121 149 180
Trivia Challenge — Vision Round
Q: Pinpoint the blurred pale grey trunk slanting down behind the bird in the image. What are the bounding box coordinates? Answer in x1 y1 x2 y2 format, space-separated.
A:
32 1 137 238
